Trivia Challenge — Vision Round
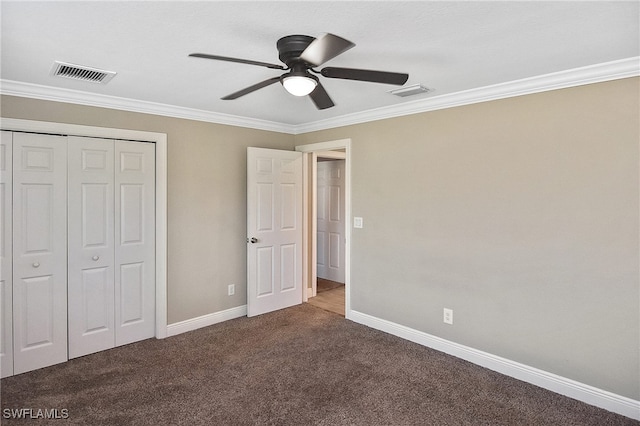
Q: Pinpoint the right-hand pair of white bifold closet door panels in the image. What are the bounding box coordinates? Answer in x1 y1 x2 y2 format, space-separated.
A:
69 137 155 358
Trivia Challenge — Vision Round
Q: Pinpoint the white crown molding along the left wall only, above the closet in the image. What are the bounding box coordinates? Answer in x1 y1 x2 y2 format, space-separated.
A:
0 79 294 134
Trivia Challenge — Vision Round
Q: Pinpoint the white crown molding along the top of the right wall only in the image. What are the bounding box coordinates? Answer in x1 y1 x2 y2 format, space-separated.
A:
295 56 640 134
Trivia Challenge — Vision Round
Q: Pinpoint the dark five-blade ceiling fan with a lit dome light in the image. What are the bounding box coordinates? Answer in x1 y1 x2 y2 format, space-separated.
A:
189 33 409 109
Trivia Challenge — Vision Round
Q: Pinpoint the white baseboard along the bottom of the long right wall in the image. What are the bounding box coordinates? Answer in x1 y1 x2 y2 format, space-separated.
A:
348 310 640 420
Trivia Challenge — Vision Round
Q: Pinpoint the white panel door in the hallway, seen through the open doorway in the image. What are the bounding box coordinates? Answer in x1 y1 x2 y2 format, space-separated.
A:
317 160 345 283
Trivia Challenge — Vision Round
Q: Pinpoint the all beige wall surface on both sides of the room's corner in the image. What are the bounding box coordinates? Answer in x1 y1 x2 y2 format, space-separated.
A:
2 75 640 400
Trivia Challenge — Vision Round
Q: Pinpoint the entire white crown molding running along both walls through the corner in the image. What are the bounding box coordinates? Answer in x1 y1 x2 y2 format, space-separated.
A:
0 56 640 134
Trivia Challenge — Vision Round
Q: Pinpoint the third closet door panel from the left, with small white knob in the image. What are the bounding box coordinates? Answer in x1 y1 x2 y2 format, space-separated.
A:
68 137 115 358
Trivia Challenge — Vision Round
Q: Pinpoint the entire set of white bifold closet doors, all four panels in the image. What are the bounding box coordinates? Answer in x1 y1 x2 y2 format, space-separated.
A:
0 131 155 377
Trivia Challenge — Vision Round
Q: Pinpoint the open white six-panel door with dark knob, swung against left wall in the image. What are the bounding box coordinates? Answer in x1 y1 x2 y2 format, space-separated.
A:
247 148 303 316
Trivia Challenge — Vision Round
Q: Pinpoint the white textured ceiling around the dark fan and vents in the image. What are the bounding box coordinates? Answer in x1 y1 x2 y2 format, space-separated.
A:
0 1 640 125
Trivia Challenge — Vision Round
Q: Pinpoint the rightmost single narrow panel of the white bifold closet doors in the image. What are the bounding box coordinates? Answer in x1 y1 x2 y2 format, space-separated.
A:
115 141 155 346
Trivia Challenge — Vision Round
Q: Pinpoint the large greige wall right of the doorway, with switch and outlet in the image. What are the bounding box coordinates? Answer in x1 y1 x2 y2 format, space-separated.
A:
296 79 640 400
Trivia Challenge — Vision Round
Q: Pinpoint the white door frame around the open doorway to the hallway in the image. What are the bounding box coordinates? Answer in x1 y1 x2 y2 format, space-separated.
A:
295 138 351 319
